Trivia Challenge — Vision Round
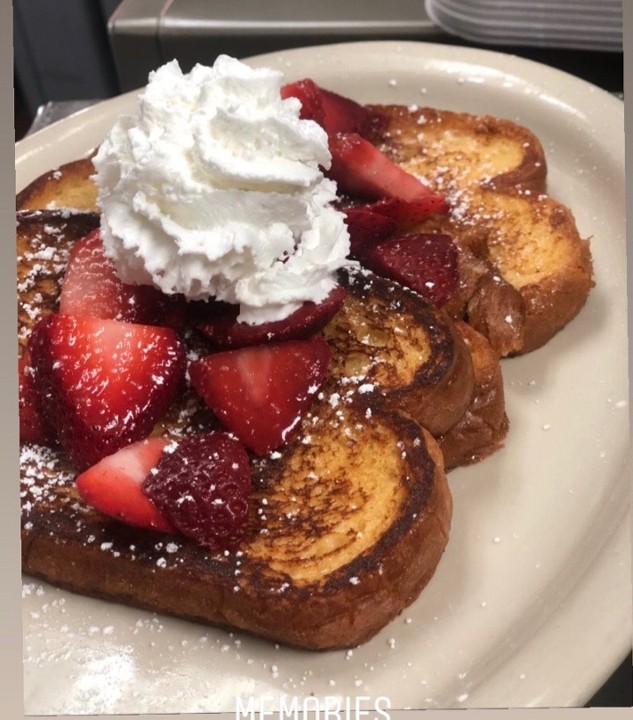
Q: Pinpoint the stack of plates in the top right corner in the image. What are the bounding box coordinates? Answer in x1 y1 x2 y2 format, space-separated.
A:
426 0 623 52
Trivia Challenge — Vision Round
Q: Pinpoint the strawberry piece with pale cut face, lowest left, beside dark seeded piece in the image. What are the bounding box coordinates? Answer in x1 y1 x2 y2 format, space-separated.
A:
76 437 175 532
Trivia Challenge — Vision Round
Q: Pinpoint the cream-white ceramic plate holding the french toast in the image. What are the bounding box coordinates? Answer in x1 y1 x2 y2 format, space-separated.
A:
16 42 632 715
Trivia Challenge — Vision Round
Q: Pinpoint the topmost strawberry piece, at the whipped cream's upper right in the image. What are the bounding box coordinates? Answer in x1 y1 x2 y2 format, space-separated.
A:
281 78 386 138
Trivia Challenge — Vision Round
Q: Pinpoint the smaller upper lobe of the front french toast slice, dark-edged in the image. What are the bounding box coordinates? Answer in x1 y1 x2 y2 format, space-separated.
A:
325 271 474 435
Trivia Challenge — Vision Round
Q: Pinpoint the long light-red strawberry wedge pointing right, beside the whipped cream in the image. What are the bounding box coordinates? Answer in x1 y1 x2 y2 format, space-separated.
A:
327 133 435 201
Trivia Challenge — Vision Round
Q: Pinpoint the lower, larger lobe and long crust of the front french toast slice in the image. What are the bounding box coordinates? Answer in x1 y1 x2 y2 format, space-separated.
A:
22 402 451 649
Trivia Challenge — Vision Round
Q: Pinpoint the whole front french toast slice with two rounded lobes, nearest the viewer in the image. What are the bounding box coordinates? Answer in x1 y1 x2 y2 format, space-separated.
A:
18 210 454 649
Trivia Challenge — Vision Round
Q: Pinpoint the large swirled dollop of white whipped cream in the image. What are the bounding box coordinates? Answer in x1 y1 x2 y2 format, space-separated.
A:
93 55 349 324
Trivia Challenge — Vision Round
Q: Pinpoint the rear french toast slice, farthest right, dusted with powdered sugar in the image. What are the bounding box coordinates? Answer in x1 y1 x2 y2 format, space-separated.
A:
374 105 593 356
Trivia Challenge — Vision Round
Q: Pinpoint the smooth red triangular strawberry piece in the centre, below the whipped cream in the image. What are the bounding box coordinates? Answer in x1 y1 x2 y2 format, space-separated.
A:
189 336 330 455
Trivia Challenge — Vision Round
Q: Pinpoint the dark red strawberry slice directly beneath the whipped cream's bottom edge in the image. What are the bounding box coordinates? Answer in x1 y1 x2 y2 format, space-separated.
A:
198 285 347 350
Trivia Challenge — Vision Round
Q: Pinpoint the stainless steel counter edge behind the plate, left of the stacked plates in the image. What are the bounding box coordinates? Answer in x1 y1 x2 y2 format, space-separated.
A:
108 0 446 91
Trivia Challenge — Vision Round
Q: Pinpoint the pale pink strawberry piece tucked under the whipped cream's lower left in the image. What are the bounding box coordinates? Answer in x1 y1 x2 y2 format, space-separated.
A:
59 229 185 327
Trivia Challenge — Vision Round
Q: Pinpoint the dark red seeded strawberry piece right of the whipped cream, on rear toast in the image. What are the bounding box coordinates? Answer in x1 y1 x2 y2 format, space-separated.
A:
367 233 459 307
